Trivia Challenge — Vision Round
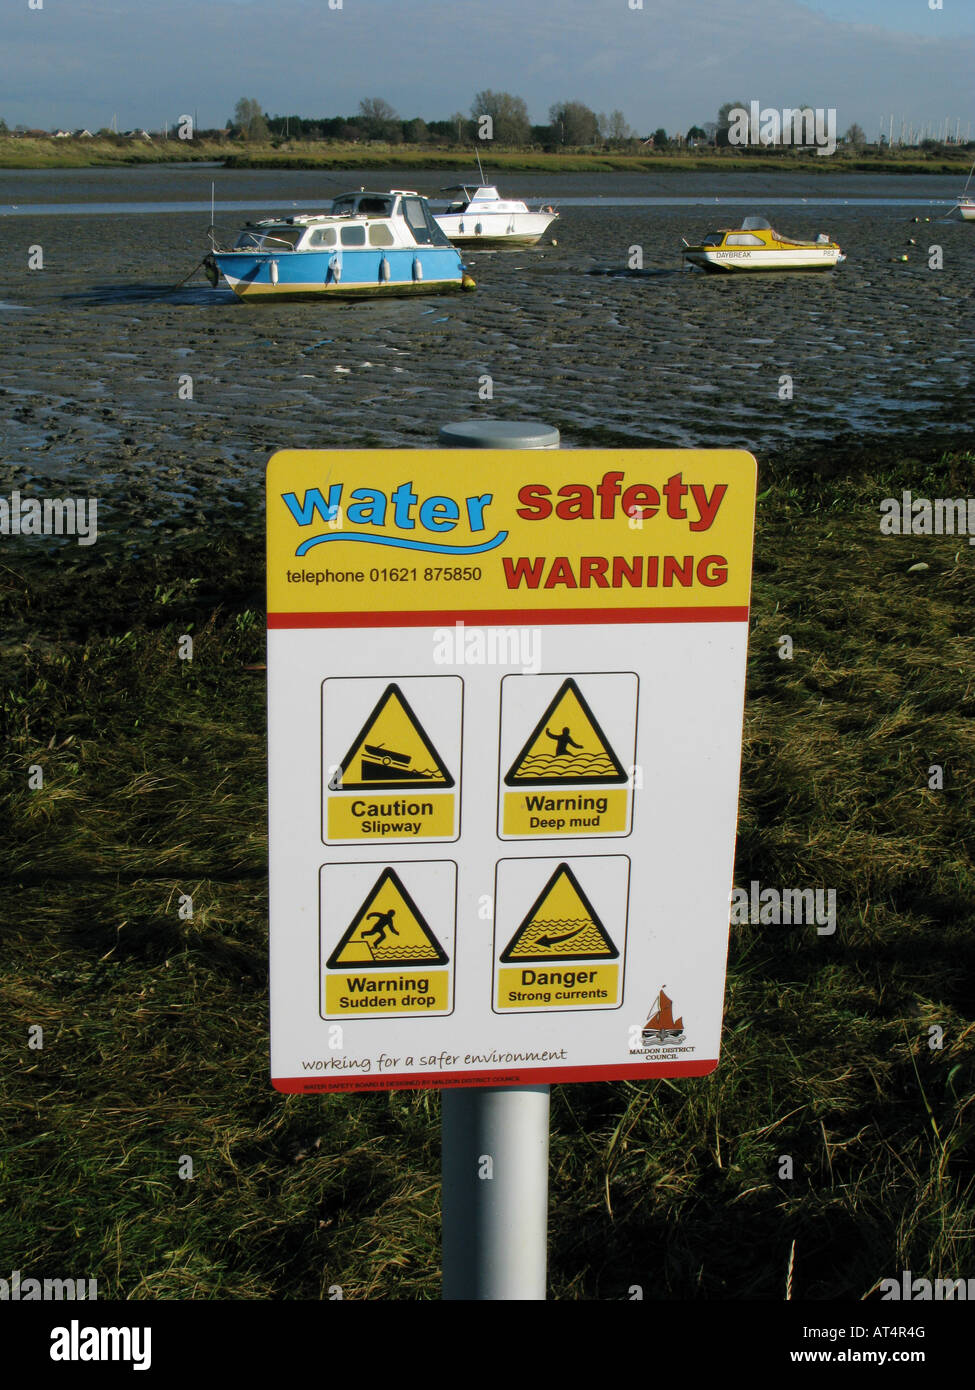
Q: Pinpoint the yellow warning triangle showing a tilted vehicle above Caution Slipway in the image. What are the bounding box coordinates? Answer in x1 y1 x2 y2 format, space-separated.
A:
328 682 453 791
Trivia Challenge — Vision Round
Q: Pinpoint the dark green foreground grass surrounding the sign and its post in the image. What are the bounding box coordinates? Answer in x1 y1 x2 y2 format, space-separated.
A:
0 447 975 1300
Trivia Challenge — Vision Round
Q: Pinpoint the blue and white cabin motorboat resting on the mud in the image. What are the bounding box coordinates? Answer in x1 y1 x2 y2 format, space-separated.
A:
203 188 474 300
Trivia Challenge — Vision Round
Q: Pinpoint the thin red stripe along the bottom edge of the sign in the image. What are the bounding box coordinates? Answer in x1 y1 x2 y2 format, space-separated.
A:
271 1056 718 1095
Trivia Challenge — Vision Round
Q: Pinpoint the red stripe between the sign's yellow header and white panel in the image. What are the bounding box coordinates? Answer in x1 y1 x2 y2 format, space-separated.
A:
267 607 748 628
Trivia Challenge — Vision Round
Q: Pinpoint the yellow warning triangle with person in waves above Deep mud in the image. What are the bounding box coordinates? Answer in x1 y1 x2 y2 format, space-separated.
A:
505 677 627 787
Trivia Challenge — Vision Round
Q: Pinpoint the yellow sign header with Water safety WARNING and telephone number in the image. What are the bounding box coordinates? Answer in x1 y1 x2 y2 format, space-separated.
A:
267 449 757 626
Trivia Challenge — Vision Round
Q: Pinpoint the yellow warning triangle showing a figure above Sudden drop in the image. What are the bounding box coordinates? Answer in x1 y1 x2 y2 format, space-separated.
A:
325 869 448 970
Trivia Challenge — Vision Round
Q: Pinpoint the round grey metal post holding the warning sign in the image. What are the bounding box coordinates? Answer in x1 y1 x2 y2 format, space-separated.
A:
438 420 559 1300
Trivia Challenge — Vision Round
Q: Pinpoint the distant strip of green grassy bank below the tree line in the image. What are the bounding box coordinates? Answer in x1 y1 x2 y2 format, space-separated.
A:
0 136 971 177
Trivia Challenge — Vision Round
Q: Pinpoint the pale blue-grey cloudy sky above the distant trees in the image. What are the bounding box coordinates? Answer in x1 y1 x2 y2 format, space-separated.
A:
0 0 975 136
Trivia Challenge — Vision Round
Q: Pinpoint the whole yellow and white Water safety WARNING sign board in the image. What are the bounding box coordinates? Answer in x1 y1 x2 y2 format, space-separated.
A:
267 449 755 1093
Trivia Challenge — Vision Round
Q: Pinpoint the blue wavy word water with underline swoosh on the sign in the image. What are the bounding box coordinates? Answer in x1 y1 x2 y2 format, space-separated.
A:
274 481 508 556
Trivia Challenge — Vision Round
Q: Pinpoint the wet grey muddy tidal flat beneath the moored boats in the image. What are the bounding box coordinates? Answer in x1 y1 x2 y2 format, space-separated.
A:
0 167 975 522
